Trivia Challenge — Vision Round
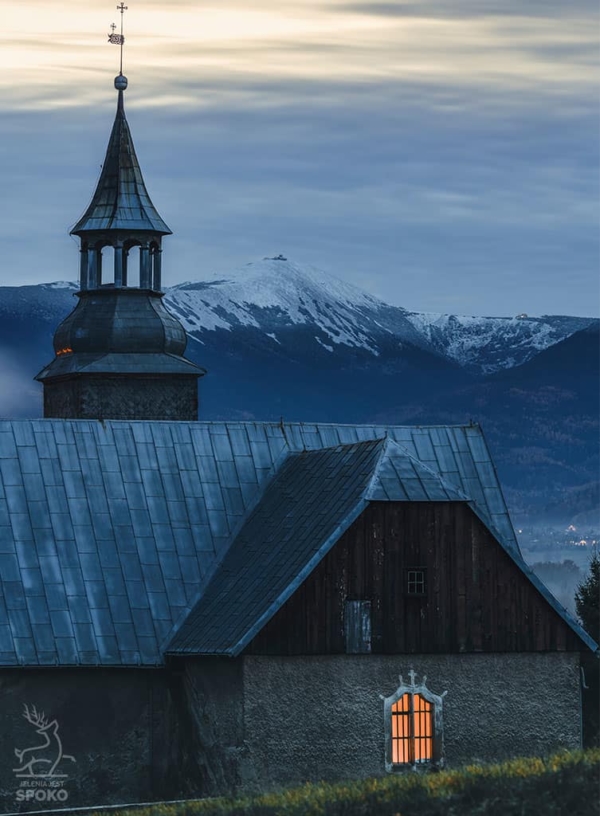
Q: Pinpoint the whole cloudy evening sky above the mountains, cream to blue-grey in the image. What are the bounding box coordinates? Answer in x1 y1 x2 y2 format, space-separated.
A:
0 0 600 316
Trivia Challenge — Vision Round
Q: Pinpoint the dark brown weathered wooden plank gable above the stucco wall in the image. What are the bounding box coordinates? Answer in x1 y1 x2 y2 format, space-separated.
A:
246 502 582 654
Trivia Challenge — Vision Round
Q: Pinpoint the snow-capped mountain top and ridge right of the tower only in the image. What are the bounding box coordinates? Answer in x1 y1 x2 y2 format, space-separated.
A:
166 256 595 374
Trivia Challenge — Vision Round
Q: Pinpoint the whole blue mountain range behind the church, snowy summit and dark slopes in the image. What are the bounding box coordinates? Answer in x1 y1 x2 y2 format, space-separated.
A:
0 256 600 514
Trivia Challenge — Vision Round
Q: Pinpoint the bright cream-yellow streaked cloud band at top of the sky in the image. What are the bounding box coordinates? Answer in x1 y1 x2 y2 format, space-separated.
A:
0 0 597 109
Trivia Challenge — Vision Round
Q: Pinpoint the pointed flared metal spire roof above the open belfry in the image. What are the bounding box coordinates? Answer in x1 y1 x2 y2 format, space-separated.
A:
71 90 171 235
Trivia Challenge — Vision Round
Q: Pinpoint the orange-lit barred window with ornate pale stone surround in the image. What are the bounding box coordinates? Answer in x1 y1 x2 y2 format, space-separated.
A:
382 669 446 771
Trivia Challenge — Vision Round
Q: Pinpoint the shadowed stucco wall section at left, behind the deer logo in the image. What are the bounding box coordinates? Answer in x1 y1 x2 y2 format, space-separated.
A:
0 668 185 812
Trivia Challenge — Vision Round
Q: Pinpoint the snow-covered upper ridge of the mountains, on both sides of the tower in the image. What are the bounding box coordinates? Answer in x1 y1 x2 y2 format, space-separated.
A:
16 255 598 375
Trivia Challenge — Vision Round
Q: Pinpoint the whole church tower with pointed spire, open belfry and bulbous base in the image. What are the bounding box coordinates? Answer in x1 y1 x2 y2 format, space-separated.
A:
36 73 206 420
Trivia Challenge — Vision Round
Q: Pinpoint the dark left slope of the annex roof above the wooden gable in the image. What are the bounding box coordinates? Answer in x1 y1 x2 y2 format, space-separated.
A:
168 440 385 655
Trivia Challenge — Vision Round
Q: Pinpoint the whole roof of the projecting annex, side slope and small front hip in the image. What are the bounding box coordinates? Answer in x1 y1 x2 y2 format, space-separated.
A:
166 439 595 657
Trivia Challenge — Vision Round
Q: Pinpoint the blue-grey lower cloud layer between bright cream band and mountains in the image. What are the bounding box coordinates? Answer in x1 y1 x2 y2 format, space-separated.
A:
0 64 598 314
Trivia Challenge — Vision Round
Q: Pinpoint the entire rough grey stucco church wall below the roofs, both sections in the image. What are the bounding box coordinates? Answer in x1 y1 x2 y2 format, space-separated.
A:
0 653 580 812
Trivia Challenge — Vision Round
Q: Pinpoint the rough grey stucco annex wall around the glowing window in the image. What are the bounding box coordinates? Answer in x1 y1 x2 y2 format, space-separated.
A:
241 653 581 787
